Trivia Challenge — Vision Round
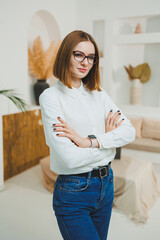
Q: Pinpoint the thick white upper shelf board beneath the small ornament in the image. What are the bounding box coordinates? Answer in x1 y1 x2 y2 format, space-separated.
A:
113 32 160 45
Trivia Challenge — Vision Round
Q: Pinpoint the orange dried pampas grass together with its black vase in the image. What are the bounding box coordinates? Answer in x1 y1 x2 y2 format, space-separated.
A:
28 37 60 105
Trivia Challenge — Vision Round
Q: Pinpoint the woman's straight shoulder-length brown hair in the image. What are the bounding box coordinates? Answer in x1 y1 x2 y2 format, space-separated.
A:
53 30 101 91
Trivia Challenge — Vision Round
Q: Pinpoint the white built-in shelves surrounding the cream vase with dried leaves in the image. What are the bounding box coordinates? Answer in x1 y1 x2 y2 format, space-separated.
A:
112 15 160 119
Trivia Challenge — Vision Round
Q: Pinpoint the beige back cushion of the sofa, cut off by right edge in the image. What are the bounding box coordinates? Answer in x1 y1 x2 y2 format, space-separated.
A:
142 118 160 140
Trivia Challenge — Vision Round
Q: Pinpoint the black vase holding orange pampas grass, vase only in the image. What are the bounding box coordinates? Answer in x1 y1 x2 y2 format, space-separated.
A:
34 79 49 105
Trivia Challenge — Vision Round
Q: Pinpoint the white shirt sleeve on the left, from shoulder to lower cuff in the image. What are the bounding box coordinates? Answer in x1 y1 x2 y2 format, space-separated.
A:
39 92 110 168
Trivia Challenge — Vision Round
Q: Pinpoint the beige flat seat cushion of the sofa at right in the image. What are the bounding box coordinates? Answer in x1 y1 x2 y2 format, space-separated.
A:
124 138 160 153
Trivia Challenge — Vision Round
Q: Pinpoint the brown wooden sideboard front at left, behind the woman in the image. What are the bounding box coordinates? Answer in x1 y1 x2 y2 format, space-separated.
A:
3 110 49 180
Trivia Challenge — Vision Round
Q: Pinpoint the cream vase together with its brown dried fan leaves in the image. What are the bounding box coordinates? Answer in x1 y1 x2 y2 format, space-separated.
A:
124 63 151 104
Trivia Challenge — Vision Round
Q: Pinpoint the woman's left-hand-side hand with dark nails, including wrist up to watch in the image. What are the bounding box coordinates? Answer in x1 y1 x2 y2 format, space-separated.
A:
53 117 91 148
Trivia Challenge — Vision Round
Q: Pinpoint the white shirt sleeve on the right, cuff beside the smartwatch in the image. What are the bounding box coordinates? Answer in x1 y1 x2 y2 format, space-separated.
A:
97 90 135 149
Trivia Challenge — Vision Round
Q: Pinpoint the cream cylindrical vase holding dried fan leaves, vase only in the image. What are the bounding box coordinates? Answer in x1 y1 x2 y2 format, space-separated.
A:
130 79 142 105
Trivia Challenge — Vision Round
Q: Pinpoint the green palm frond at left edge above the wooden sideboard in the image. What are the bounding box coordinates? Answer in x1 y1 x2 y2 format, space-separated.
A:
0 89 28 112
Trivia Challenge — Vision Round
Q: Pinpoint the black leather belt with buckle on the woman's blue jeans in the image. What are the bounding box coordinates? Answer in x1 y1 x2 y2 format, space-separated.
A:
71 162 111 177
